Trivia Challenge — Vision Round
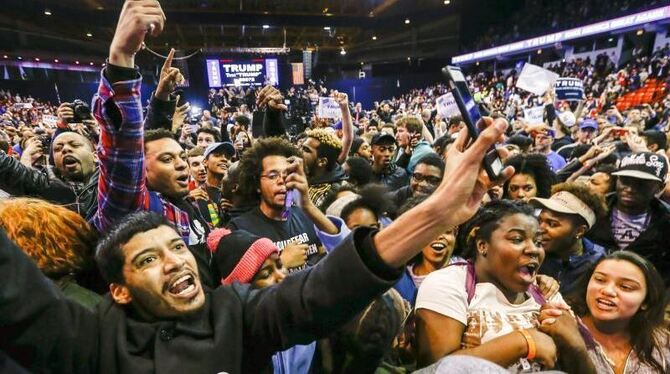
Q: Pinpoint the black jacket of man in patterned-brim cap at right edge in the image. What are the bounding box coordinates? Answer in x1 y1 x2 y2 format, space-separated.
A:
586 193 670 287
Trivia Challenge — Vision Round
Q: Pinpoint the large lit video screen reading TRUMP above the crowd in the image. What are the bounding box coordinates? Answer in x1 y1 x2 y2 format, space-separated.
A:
207 58 279 88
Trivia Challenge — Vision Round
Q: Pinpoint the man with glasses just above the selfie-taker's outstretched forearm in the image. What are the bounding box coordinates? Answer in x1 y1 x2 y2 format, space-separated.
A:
389 153 444 207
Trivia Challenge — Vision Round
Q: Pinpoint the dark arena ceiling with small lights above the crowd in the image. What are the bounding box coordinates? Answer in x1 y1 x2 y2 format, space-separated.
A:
0 0 466 62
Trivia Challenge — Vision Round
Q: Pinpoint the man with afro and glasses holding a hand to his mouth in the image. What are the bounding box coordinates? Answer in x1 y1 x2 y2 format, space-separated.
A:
230 138 340 271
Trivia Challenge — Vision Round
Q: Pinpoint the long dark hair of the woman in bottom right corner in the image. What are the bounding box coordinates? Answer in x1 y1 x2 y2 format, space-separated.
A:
566 251 669 373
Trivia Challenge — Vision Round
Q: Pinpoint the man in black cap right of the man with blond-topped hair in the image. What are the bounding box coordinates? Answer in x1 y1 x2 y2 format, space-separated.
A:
371 133 409 191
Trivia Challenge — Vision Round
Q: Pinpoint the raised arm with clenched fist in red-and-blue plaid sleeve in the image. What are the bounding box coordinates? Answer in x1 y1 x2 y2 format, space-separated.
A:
93 0 165 232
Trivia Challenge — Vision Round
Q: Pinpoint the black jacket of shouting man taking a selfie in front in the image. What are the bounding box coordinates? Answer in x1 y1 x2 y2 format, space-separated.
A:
0 228 402 374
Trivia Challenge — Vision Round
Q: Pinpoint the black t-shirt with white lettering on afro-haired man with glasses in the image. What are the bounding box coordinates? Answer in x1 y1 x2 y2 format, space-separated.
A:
230 207 324 271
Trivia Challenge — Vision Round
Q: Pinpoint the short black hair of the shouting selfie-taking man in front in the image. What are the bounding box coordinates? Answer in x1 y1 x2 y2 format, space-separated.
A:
95 211 174 284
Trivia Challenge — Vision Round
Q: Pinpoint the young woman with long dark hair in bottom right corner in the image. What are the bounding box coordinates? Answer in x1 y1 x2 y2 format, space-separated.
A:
560 251 670 374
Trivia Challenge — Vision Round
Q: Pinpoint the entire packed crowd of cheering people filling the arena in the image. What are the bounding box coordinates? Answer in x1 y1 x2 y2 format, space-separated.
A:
0 1 670 373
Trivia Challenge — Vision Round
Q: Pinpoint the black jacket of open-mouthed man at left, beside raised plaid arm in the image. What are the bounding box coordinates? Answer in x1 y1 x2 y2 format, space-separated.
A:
0 151 99 220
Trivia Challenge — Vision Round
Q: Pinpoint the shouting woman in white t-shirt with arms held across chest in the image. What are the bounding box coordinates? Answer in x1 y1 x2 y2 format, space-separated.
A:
416 200 588 373
